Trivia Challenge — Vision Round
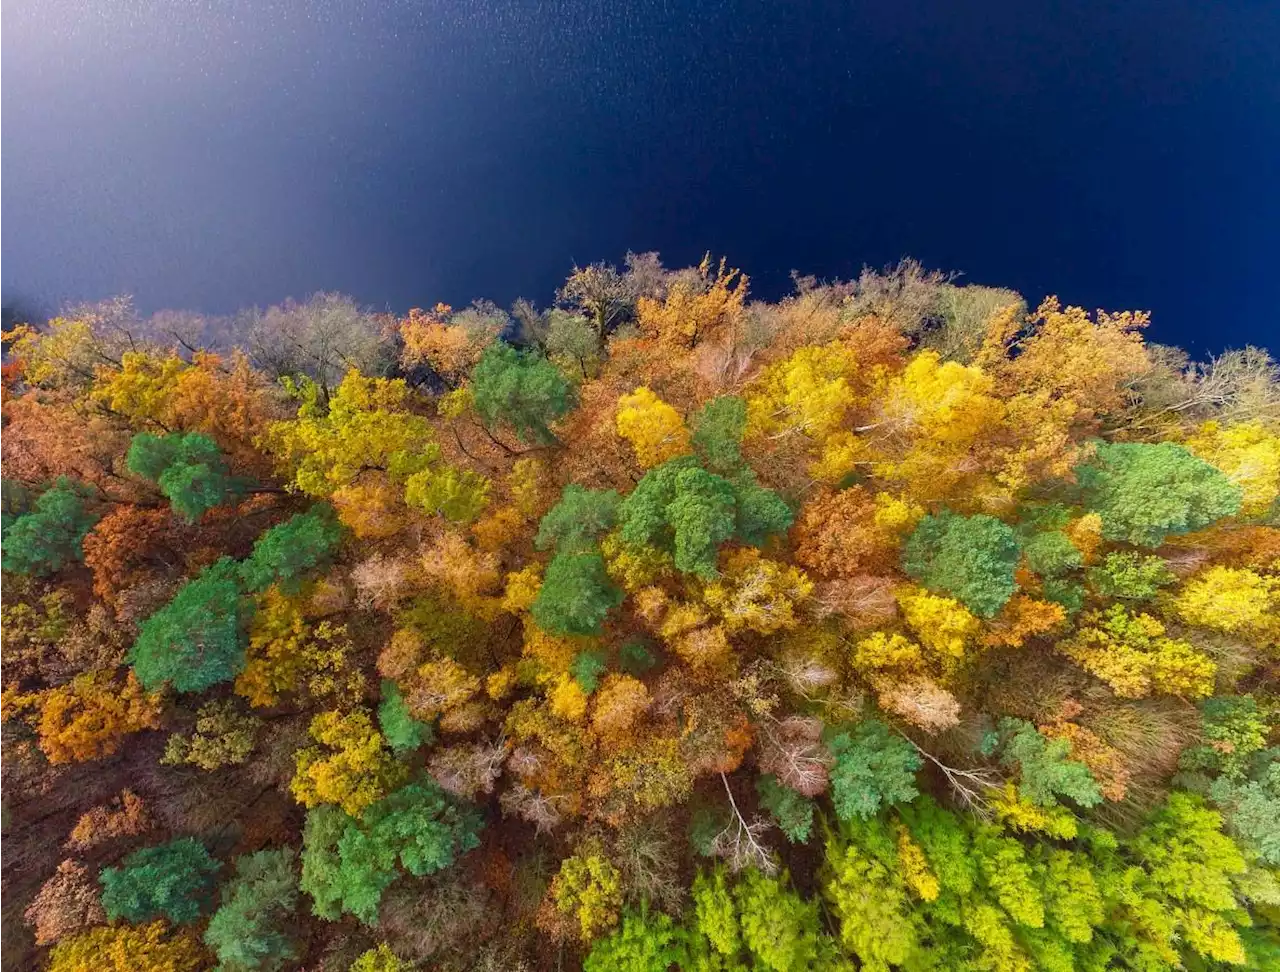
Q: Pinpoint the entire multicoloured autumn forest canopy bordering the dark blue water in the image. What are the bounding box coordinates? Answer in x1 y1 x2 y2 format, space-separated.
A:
0 254 1280 972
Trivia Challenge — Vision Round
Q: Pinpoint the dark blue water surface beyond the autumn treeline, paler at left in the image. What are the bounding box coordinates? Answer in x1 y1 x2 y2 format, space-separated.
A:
0 0 1280 352
